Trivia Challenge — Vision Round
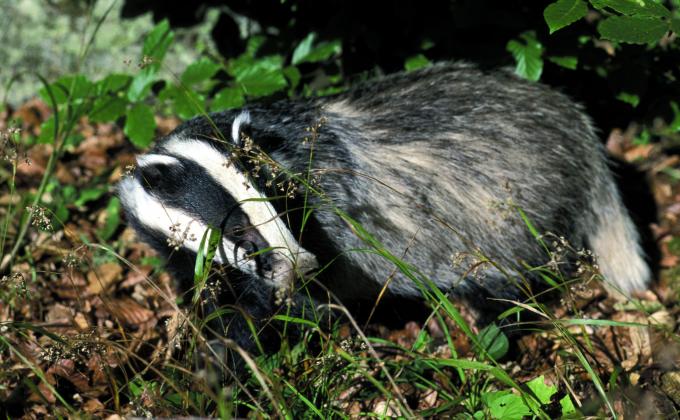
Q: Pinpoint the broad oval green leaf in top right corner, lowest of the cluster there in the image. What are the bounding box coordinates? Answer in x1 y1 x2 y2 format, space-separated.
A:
597 16 669 44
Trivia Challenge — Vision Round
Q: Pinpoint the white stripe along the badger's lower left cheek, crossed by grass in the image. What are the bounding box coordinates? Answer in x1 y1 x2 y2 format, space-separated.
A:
118 178 257 275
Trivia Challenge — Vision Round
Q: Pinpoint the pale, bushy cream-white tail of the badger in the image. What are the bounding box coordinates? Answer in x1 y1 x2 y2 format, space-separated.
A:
588 176 651 296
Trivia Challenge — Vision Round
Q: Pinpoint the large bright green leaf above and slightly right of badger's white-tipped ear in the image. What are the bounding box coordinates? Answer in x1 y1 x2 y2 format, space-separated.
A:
236 56 288 97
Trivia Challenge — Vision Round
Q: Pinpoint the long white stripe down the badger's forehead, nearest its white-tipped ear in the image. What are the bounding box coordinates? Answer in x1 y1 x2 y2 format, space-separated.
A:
163 137 307 270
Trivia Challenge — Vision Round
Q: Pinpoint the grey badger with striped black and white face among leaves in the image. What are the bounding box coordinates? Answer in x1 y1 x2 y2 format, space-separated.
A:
118 63 650 364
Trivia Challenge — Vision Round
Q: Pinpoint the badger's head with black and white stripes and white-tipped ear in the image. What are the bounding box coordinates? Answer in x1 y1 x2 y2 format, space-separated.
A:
118 113 318 287
